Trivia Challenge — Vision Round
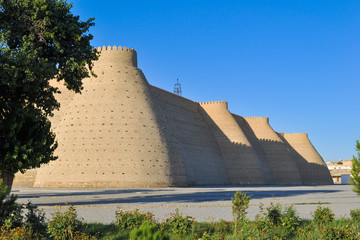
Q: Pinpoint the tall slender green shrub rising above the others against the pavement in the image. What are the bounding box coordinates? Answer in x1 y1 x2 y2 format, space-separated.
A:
231 192 250 235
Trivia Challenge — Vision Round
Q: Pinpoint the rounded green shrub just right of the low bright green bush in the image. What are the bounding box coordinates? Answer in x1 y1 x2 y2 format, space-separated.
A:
163 209 194 235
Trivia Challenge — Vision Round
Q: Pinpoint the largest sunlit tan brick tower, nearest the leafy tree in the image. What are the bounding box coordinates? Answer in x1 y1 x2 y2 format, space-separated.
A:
35 48 187 187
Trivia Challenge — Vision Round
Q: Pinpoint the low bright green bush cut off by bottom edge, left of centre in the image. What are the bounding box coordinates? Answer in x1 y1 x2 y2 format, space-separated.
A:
130 221 170 240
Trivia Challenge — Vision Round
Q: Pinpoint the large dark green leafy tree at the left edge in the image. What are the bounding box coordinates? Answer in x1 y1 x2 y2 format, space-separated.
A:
0 0 98 187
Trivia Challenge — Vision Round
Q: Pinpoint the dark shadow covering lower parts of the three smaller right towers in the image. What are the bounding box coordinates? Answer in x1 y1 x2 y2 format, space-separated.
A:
200 107 332 185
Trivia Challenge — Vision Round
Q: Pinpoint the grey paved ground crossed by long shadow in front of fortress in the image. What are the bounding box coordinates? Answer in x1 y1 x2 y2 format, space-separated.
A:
12 185 360 223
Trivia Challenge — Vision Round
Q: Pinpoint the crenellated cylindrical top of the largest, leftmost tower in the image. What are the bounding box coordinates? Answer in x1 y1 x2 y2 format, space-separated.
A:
94 46 137 68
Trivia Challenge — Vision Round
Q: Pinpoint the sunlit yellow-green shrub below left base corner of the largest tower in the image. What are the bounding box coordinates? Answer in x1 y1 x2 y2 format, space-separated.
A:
48 205 82 240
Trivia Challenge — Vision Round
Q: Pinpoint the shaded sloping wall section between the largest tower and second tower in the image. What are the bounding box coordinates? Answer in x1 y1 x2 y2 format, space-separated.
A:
151 86 230 185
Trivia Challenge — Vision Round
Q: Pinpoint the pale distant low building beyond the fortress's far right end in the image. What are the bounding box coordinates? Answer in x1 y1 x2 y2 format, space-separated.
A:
326 159 352 184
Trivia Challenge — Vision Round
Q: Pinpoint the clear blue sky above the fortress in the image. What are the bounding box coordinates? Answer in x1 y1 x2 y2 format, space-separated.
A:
72 0 360 161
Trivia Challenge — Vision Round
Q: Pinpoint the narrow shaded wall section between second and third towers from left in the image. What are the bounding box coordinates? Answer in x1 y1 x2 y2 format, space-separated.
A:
232 114 274 184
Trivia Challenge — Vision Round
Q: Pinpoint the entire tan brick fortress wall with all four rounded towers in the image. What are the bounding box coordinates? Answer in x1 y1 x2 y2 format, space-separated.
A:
14 47 332 187
